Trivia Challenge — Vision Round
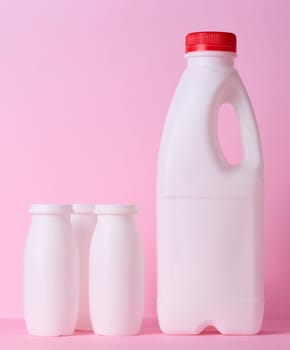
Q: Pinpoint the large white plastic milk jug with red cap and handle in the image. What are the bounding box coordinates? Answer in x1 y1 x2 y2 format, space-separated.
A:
157 32 264 334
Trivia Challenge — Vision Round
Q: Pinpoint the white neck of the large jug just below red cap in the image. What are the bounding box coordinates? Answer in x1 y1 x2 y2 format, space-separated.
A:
185 51 236 69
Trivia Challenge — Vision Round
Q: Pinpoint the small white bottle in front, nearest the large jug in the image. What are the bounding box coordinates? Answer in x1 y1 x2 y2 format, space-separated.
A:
89 204 144 335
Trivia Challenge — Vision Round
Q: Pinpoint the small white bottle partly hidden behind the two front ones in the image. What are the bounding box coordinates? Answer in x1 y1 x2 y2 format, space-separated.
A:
71 204 97 330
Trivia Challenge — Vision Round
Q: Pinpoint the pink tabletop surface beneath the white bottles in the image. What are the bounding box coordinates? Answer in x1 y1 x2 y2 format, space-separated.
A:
0 319 290 350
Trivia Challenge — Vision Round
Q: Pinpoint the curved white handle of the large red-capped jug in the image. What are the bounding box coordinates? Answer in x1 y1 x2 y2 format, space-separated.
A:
216 74 263 170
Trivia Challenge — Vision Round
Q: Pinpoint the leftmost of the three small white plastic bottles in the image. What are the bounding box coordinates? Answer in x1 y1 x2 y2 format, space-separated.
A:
23 204 78 336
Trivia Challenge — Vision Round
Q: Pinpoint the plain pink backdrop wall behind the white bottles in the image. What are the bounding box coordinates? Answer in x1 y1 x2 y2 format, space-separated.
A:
0 0 290 319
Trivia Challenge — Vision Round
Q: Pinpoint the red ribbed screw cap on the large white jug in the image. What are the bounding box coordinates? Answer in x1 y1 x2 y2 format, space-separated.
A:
185 32 237 53
